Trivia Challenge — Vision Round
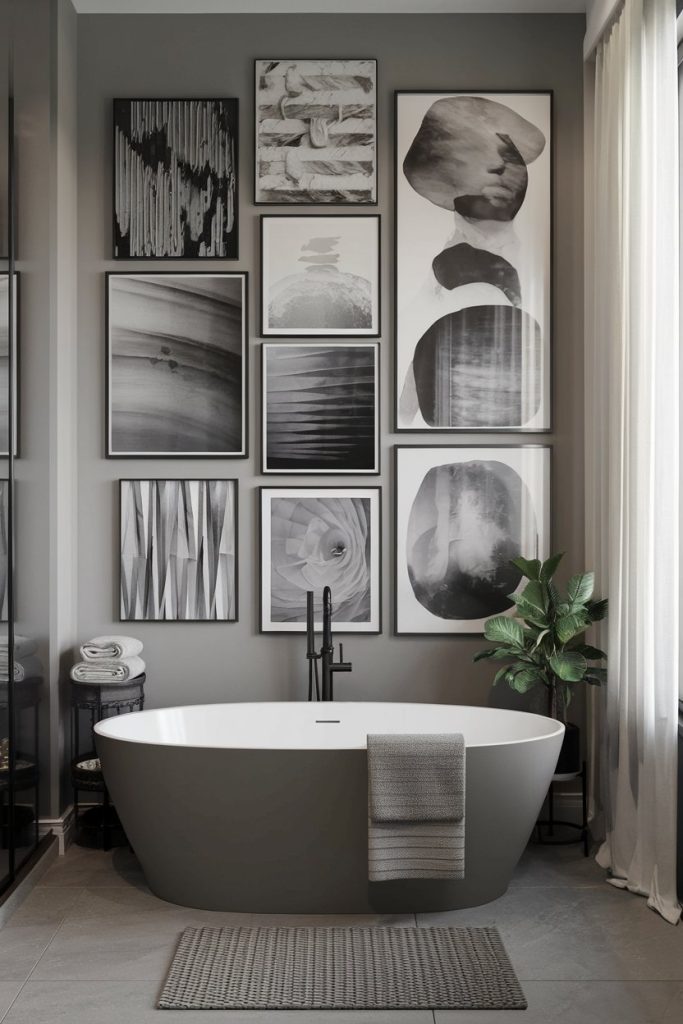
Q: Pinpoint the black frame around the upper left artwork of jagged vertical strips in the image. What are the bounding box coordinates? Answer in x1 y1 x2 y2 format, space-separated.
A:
112 96 240 261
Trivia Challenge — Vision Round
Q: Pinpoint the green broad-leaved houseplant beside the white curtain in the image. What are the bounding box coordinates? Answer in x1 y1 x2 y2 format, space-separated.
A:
474 553 607 760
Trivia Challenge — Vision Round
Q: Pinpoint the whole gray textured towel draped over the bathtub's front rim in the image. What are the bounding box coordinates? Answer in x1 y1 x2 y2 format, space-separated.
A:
368 733 465 882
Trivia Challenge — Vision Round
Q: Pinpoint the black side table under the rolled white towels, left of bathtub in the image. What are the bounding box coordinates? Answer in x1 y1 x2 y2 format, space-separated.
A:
71 673 146 850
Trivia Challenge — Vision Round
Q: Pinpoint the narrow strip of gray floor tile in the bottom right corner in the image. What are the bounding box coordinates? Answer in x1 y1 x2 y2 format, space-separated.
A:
435 981 683 1024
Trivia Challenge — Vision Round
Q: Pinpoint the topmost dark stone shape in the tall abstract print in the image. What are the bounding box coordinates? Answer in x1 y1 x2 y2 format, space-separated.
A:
403 96 546 221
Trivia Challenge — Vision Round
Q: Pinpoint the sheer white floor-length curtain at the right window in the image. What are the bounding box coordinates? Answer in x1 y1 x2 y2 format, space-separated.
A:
586 0 681 923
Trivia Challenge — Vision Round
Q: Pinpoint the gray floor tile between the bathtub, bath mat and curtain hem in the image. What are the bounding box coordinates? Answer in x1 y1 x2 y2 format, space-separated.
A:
418 884 683 981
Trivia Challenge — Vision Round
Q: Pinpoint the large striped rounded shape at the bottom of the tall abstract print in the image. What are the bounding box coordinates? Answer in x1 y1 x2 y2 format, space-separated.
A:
413 305 543 429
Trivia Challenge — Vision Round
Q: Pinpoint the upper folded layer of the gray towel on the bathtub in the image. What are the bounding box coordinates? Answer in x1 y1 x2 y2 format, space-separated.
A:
368 732 465 822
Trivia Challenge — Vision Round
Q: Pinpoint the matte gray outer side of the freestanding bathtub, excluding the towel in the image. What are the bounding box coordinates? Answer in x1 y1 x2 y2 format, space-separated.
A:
96 713 562 913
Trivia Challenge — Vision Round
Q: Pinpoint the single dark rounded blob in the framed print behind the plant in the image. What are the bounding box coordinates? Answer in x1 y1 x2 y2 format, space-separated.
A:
405 460 535 620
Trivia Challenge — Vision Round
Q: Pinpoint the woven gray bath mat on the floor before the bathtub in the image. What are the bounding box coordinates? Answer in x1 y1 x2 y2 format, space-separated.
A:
158 928 526 1010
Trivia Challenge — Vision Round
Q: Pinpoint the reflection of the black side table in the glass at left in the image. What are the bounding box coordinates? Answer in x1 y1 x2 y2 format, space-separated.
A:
0 676 43 850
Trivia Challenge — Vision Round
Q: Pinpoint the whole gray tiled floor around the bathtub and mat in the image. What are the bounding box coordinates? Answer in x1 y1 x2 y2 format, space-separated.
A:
0 847 683 1024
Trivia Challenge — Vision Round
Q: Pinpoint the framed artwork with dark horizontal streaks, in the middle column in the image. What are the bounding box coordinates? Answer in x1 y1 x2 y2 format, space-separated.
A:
261 341 380 474
